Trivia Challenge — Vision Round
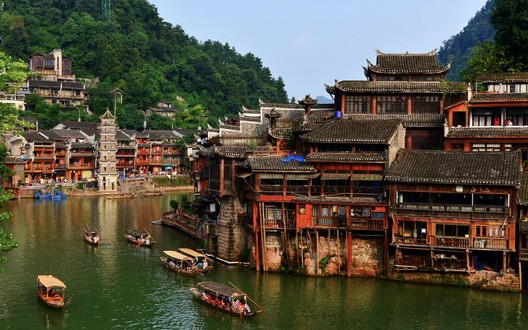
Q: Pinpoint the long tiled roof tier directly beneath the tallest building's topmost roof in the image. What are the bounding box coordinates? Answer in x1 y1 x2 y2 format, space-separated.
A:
326 80 456 94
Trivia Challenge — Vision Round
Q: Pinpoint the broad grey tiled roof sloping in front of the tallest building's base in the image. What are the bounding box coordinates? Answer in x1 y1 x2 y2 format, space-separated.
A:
301 119 401 144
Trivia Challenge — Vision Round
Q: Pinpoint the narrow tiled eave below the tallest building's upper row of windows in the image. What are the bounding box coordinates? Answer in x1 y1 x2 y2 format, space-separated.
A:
345 113 446 127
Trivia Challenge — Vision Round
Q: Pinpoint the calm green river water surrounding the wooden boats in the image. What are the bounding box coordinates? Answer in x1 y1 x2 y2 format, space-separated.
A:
0 194 528 330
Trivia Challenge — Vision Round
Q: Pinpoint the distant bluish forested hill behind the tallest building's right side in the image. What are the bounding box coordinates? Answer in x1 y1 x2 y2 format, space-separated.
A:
438 0 495 81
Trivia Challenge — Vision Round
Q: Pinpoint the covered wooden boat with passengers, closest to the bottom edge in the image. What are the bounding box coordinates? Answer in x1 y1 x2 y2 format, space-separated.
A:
190 281 264 317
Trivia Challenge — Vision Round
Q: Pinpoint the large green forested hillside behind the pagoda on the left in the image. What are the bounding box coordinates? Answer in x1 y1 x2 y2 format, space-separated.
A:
0 0 288 129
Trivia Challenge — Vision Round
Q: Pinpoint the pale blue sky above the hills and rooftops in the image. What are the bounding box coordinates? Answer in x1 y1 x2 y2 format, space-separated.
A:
148 0 487 102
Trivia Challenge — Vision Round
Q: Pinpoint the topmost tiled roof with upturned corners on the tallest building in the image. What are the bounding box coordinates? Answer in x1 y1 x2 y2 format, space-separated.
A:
367 51 449 74
